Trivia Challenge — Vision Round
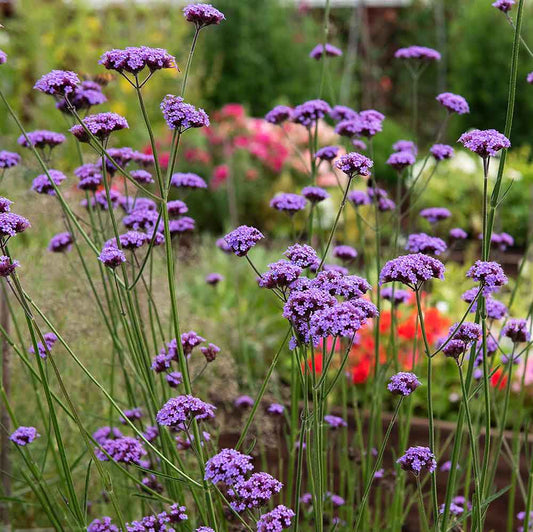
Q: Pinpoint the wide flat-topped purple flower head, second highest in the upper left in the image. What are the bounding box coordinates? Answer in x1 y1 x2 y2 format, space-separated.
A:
99 46 176 75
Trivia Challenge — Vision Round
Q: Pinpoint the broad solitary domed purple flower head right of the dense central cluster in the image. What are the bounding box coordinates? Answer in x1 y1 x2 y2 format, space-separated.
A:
379 253 444 290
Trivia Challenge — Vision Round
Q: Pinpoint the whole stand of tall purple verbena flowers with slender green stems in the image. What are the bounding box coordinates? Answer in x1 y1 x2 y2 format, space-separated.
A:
0 0 533 532
